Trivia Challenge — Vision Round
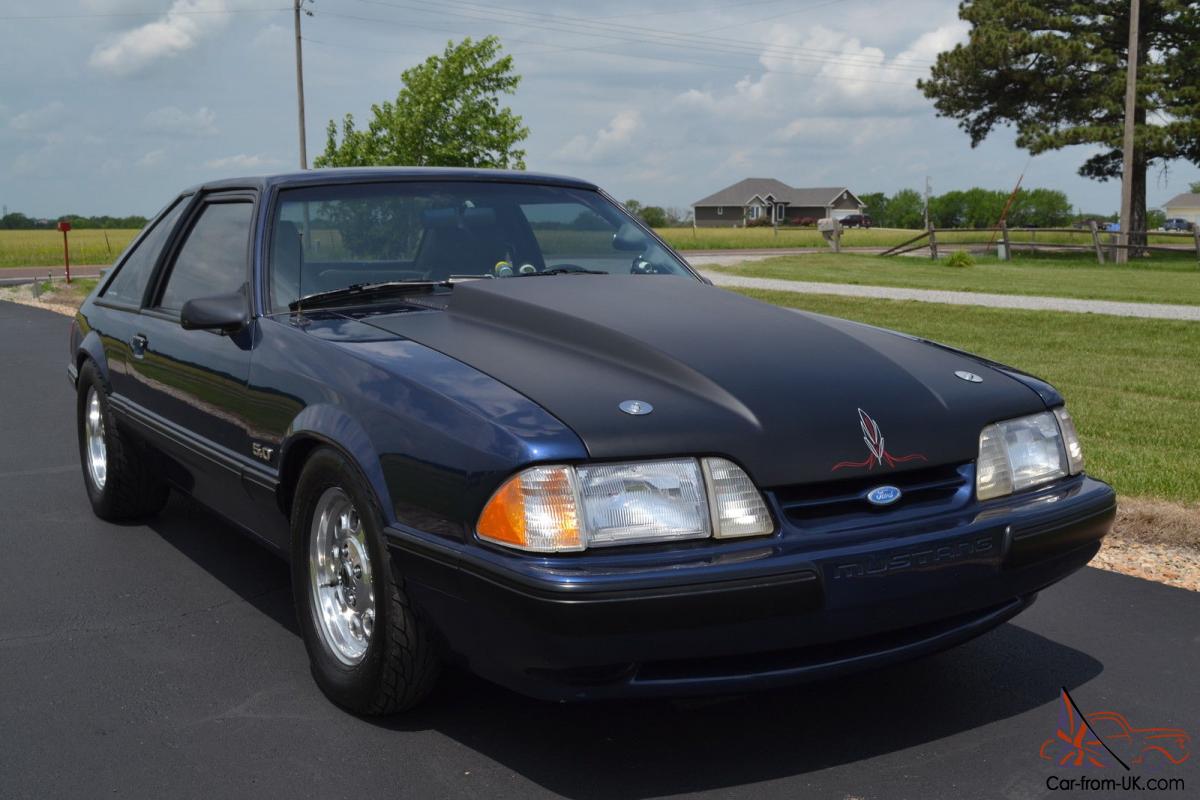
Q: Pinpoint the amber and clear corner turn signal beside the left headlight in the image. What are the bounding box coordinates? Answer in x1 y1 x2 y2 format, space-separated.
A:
476 467 583 553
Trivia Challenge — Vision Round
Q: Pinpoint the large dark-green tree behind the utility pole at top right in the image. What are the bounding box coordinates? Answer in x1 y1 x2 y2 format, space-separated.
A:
917 0 1200 241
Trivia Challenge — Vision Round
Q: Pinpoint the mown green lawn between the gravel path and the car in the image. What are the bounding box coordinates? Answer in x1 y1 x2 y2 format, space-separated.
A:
740 289 1200 503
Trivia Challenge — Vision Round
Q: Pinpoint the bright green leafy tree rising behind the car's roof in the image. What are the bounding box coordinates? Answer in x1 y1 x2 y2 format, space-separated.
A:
313 36 529 169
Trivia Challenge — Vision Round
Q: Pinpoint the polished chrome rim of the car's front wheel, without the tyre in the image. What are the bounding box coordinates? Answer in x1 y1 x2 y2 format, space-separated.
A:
308 487 376 667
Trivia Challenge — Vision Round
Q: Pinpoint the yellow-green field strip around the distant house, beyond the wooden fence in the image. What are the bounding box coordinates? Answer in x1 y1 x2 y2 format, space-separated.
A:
654 227 1195 254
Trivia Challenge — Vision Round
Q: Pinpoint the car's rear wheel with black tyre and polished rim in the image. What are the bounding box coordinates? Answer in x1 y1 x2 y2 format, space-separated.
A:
76 361 170 522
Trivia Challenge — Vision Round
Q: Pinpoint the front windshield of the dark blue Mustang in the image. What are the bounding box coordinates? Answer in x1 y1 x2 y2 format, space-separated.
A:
262 181 691 312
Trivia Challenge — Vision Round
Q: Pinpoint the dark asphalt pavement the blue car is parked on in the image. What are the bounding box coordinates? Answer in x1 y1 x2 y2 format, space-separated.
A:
0 302 1200 800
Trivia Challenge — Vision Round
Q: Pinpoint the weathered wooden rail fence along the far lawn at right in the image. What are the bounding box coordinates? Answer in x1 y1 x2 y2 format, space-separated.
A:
881 222 1200 264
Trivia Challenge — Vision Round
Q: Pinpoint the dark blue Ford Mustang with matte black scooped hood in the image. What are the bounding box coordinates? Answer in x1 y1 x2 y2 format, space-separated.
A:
68 169 1115 714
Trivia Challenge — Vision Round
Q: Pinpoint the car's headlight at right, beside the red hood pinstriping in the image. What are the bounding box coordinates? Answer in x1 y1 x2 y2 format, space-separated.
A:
976 408 1084 500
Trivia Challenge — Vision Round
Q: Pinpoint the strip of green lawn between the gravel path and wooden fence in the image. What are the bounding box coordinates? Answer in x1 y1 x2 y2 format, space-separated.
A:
703 253 1200 305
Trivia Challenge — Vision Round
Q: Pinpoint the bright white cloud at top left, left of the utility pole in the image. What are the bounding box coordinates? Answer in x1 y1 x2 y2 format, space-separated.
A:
90 0 229 74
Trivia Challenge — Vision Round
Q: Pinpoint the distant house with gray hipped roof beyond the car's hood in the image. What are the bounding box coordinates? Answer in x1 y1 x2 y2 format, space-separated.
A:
691 178 866 228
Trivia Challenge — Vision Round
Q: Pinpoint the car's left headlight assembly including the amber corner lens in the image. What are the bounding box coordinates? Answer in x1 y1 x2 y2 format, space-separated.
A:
475 458 775 553
